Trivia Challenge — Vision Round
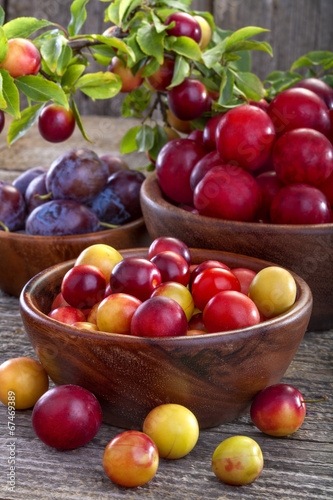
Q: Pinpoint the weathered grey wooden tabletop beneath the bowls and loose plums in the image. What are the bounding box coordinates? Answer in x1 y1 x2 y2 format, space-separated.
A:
0 117 333 500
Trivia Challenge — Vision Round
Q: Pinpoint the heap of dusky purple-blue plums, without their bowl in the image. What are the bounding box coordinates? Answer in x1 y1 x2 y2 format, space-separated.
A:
0 148 145 236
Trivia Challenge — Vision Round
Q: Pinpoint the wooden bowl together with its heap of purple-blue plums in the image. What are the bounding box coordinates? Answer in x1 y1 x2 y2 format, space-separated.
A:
0 148 146 296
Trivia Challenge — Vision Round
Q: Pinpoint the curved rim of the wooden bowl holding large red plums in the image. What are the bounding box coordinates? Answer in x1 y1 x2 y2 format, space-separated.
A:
141 171 333 233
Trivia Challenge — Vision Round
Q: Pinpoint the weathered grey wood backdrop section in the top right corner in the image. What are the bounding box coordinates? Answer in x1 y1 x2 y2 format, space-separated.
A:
213 0 333 78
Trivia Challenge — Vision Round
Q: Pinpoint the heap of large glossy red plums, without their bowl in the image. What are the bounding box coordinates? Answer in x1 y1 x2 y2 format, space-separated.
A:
156 78 333 224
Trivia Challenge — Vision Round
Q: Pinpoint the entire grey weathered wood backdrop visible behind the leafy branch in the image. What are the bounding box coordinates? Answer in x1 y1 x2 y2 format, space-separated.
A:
0 0 333 116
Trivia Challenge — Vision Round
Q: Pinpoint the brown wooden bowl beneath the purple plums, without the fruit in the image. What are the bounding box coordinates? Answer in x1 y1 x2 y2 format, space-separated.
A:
0 217 148 297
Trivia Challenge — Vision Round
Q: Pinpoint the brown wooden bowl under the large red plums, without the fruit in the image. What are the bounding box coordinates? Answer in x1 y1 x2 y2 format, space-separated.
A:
141 173 333 330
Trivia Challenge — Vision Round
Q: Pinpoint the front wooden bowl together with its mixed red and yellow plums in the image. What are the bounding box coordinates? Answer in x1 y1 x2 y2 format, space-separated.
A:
20 237 312 428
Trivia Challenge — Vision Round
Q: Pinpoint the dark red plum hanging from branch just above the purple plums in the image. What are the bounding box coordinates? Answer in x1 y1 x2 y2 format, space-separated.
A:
38 104 75 143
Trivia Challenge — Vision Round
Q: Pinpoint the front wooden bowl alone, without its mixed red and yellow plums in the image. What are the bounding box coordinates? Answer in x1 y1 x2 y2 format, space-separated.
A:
20 248 312 429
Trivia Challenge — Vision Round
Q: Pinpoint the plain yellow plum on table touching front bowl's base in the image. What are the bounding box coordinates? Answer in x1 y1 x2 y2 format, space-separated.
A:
143 404 197 459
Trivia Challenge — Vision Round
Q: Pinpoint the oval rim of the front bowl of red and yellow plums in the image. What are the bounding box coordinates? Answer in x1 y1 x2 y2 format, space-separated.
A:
19 247 313 345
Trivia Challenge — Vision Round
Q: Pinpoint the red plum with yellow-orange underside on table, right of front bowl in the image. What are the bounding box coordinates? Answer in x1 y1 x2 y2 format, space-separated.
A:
250 384 306 436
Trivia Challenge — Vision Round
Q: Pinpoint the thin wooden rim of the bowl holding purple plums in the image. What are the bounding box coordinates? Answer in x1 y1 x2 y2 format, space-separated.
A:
0 216 145 243
